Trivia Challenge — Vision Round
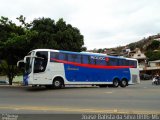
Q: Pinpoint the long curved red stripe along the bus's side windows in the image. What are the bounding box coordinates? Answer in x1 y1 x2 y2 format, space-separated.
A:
51 58 134 69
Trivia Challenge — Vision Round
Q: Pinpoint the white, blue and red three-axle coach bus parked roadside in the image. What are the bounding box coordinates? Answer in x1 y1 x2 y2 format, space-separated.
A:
17 49 140 88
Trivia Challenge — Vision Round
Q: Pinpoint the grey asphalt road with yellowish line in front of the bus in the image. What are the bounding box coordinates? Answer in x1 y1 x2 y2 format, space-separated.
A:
0 81 160 114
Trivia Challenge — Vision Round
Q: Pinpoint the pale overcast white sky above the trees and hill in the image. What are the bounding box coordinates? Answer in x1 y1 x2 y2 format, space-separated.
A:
0 0 160 50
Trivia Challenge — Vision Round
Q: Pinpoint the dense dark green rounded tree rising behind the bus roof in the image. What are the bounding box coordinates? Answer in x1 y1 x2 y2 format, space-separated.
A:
31 18 84 51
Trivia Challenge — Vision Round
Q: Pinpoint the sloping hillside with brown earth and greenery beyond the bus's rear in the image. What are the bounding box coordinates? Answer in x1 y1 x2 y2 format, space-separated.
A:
92 34 160 61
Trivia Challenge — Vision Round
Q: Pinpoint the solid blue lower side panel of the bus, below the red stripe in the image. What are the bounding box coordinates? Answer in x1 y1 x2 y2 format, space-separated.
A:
64 64 131 82
